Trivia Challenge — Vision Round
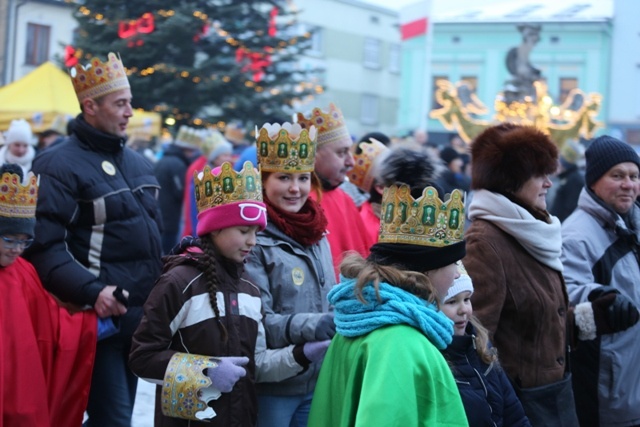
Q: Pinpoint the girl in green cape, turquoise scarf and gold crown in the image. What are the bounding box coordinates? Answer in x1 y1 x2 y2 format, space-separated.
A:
309 184 468 427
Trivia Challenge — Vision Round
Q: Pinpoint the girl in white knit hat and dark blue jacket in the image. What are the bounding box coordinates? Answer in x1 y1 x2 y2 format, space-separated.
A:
442 264 531 427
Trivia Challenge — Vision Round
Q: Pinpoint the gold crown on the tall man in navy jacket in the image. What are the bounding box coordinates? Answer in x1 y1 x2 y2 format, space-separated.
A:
69 52 130 102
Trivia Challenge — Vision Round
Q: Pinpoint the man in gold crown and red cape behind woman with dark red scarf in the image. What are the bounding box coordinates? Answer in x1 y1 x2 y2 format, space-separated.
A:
297 104 370 277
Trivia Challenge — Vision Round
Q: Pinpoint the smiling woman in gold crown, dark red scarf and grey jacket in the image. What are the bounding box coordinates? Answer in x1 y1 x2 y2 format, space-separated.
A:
247 123 335 427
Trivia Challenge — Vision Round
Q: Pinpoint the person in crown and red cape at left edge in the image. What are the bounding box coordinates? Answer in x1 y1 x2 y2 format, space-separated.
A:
0 164 97 427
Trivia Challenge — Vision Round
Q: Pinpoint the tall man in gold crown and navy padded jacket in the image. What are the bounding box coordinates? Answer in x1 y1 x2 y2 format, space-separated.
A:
27 53 161 427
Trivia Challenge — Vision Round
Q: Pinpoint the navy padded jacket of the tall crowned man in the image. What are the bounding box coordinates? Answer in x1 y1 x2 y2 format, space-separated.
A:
25 115 162 334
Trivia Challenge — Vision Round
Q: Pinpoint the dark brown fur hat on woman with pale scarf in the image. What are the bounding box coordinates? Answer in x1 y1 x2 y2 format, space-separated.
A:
471 123 558 194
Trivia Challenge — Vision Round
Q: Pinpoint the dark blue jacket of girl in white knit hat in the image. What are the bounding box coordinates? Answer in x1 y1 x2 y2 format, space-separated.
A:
443 323 531 427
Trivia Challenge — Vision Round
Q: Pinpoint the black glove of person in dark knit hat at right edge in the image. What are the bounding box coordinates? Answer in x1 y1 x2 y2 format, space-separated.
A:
589 286 640 334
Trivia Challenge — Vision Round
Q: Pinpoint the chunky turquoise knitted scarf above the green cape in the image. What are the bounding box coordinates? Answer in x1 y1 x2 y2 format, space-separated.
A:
328 277 453 350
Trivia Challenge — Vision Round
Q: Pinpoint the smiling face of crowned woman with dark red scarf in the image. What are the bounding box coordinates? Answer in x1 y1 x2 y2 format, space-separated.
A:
263 172 311 213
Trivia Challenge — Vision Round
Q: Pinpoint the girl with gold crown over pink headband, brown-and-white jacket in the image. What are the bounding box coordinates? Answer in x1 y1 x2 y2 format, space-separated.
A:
130 162 324 427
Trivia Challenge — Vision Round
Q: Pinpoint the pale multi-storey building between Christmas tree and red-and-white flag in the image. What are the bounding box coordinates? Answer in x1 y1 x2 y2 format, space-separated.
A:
297 0 400 138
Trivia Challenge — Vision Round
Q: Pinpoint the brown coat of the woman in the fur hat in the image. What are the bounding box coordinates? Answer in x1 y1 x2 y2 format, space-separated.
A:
463 219 568 388
